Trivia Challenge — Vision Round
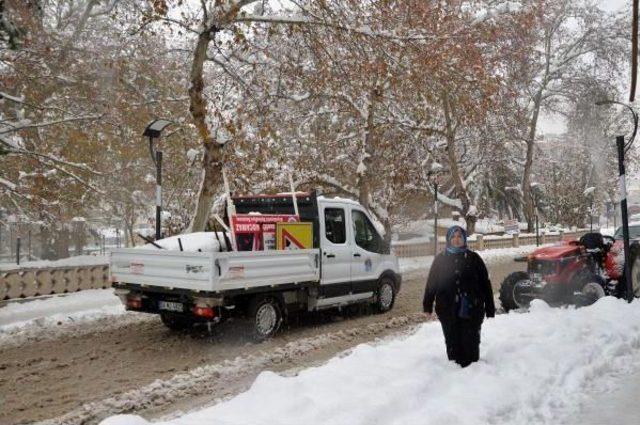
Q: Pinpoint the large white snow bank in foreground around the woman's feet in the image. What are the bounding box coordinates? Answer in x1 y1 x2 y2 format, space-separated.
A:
102 297 640 425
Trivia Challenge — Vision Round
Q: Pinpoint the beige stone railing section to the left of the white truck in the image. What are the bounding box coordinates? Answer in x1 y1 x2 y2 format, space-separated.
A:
0 264 110 300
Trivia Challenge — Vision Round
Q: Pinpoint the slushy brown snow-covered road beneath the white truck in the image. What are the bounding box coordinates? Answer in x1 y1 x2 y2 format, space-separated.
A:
0 243 531 423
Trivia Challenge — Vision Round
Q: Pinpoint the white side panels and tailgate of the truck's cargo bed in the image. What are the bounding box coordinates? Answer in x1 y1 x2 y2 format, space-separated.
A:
109 248 320 292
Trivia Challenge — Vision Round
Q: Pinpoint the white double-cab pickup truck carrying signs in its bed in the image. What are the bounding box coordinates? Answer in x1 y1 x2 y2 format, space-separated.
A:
110 192 402 339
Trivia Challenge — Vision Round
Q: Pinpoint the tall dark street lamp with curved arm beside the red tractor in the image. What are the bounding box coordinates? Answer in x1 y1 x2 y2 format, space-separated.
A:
596 100 638 302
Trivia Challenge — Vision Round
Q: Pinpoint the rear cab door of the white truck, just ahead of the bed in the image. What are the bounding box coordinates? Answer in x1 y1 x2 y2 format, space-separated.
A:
320 206 352 286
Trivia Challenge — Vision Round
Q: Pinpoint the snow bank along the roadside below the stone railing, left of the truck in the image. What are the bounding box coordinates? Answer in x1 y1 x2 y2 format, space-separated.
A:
0 289 125 336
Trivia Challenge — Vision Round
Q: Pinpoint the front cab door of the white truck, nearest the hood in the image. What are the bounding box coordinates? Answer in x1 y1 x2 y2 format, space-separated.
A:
350 208 383 286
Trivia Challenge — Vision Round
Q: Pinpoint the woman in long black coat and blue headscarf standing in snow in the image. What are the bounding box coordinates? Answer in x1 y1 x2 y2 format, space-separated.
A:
422 226 495 367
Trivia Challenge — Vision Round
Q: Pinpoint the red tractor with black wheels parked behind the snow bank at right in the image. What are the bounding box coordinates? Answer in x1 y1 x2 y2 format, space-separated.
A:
500 232 640 311
